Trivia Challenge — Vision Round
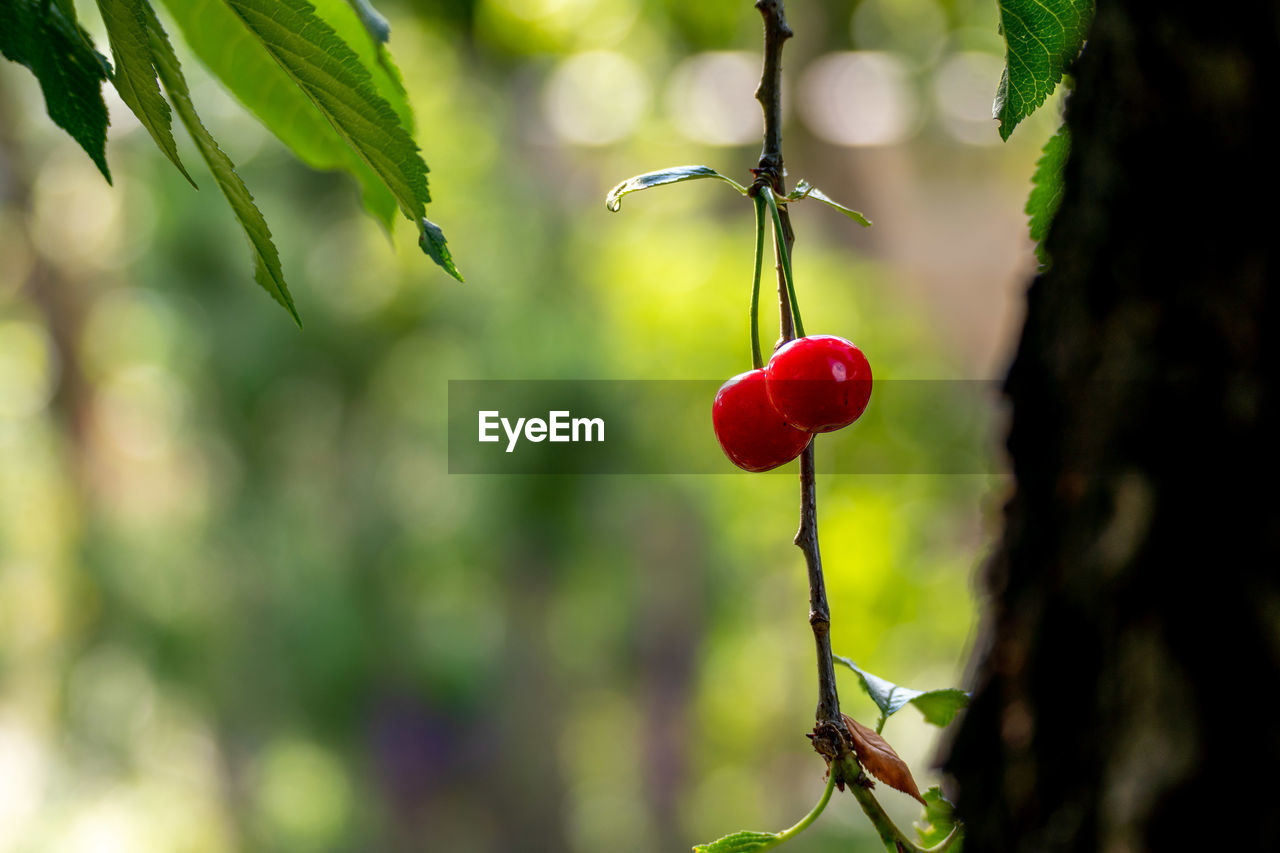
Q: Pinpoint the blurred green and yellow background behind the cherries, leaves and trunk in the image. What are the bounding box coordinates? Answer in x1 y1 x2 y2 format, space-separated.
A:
0 0 1056 853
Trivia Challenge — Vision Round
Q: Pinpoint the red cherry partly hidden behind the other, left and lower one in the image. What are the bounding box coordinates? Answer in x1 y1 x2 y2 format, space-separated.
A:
712 369 813 471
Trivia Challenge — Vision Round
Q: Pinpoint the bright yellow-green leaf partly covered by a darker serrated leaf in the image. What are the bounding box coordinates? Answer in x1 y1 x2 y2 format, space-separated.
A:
164 0 408 228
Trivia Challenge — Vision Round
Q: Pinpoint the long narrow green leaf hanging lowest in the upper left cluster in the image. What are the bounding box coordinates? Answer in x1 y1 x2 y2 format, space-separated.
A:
146 6 302 327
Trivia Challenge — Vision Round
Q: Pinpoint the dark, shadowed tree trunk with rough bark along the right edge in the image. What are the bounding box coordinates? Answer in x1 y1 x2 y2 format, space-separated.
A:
946 0 1280 853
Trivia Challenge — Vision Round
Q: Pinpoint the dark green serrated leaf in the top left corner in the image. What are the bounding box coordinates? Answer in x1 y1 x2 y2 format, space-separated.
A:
0 0 111 183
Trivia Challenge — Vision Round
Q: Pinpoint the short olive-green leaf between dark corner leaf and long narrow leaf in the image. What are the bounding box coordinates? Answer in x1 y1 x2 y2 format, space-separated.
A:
97 0 196 187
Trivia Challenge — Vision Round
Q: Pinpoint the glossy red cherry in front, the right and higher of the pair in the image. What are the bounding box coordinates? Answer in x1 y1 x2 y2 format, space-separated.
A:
764 334 872 433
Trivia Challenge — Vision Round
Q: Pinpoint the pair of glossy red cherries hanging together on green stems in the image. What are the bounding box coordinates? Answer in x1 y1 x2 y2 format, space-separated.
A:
712 334 872 471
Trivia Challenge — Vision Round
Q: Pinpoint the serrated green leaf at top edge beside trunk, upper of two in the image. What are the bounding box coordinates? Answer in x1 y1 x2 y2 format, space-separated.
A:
992 0 1093 141
